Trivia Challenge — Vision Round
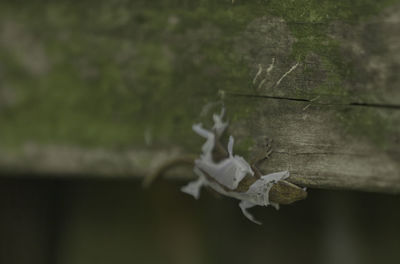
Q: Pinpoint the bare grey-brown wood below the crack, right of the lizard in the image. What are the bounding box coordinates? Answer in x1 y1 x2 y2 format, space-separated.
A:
227 94 400 192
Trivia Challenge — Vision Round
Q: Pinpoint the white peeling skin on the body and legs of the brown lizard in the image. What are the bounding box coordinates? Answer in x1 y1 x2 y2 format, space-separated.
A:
181 109 289 224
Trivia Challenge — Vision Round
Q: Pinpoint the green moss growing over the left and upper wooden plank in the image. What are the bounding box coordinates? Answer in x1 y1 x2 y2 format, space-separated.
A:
0 0 394 152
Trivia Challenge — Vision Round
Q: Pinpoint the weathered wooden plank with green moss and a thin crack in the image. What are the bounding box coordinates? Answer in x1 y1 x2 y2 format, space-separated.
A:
0 0 400 192
